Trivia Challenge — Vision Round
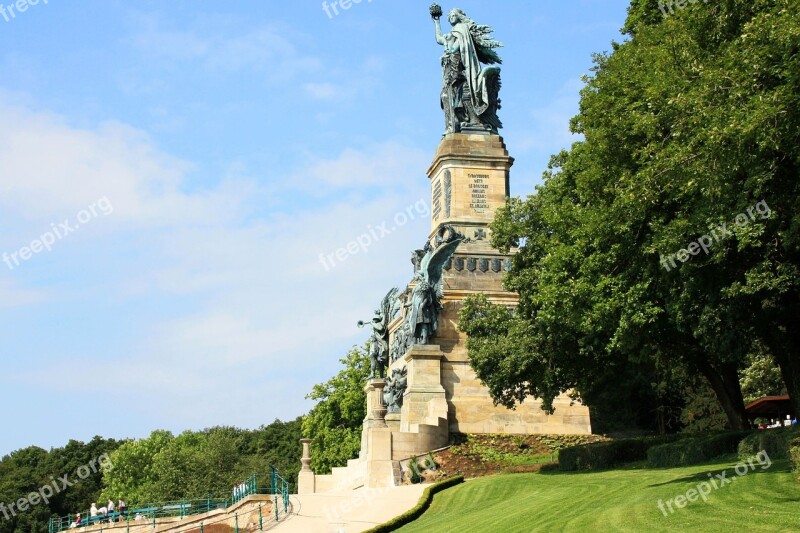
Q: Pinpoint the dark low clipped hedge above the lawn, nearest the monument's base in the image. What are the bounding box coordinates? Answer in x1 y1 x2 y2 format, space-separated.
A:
558 434 682 472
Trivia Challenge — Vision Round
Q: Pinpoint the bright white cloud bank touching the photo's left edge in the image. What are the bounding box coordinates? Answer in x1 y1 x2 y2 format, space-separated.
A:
0 94 255 226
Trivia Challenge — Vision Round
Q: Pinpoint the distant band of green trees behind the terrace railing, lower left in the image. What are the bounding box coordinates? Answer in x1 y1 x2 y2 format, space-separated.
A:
0 418 301 533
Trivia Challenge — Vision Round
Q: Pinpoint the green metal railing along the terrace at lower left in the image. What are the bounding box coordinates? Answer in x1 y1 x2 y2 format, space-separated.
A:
48 466 289 533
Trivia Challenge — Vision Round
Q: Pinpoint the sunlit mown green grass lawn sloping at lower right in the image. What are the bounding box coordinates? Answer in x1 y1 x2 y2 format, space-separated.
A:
399 456 800 533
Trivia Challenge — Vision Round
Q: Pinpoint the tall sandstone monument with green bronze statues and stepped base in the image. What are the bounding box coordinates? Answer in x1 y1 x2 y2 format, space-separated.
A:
296 4 591 492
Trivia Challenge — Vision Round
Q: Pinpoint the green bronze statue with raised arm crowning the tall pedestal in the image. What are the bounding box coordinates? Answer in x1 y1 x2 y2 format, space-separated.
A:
430 4 503 134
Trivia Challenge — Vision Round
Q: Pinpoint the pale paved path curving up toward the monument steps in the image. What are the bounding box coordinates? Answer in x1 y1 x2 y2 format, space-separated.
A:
270 485 427 533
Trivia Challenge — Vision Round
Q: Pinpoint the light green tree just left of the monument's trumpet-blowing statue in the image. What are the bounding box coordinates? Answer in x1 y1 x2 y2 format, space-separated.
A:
303 346 369 474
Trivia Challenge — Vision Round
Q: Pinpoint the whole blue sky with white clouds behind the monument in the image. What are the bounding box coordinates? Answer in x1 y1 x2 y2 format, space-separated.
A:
0 0 627 455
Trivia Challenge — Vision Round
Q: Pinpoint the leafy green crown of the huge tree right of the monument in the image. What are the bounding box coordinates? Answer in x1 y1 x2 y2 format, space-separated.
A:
461 0 800 428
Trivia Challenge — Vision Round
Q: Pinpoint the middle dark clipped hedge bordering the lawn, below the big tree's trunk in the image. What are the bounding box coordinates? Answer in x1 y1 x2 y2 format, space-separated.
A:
647 431 755 467
